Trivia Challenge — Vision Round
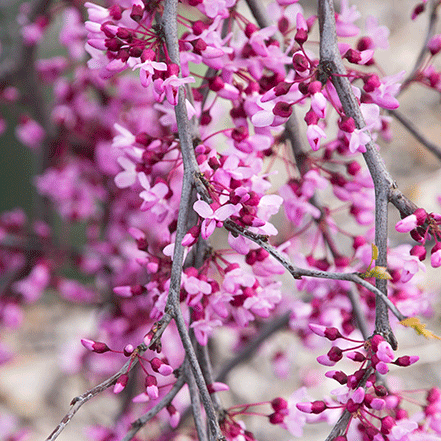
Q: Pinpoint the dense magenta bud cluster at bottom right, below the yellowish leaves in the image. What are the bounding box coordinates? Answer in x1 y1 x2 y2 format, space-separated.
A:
296 324 418 441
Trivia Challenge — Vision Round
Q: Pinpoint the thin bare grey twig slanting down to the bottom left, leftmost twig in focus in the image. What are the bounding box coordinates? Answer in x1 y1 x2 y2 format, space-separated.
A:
46 343 147 441
